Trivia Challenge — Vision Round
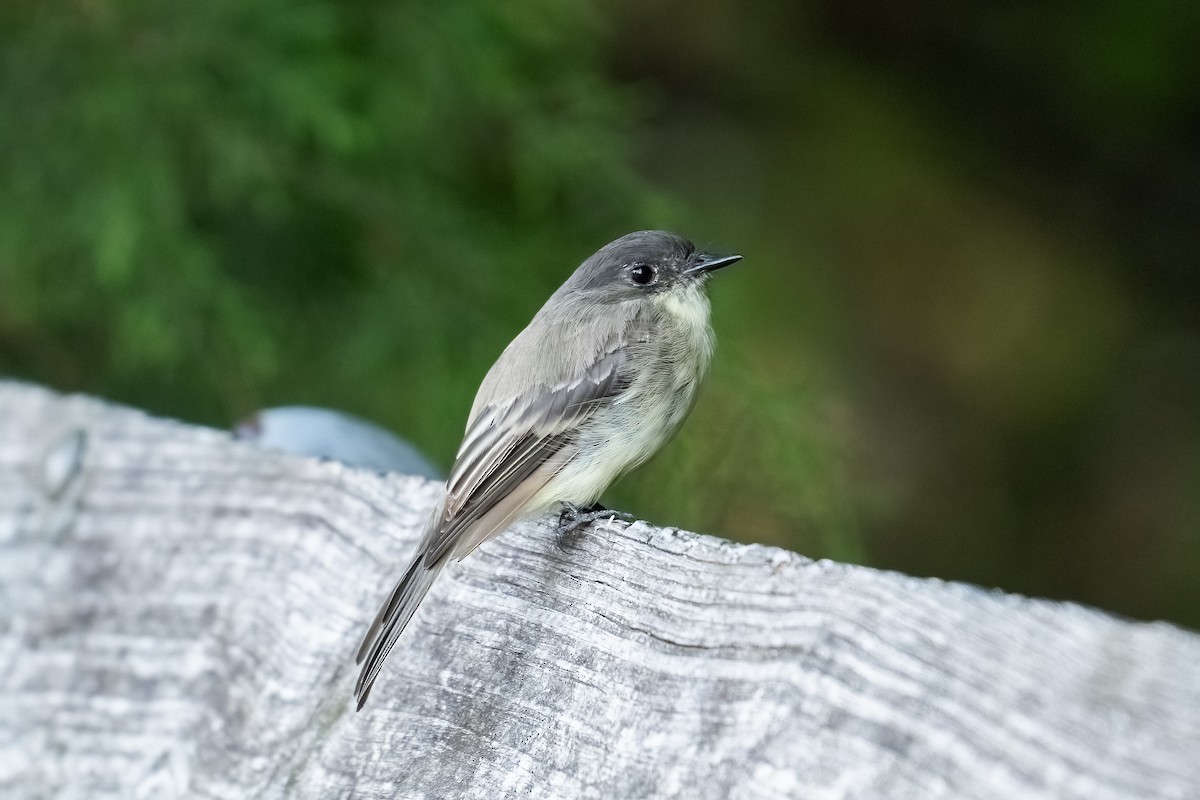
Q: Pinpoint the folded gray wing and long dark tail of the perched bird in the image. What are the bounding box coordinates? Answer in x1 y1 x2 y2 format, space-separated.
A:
354 339 630 709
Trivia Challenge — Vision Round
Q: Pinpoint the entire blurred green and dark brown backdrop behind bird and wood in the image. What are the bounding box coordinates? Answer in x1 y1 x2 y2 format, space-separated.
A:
0 0 1200 627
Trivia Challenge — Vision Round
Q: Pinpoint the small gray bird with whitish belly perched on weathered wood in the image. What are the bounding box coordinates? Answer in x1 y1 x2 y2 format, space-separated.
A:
354 230 742 709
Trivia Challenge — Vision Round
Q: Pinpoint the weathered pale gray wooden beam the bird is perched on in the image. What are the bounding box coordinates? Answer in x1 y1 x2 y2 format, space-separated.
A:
0 383 1200 800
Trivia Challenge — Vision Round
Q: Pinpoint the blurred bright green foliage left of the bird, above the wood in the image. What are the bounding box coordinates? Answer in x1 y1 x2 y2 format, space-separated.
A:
0 0 647 444
